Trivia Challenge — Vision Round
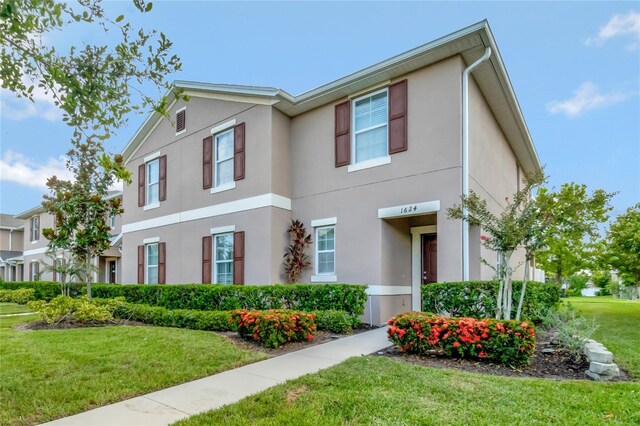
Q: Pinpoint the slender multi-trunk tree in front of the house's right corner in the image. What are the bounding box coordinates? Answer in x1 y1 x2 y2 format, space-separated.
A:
447 173 545 319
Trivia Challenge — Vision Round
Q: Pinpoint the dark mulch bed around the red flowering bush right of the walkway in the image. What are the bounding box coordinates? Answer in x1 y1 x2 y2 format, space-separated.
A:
377 332 631 382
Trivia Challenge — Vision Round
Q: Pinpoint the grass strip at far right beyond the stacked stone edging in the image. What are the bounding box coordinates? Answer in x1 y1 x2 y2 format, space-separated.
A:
565 296 640 379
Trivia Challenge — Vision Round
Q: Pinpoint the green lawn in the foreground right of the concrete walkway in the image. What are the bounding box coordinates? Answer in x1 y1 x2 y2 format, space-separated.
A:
176 356 640 426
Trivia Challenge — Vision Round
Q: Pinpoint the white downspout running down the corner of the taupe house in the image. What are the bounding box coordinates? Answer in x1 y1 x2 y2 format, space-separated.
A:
462 47 491 281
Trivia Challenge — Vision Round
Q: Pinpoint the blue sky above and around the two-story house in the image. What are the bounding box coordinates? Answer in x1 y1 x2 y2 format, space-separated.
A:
0 1 640 220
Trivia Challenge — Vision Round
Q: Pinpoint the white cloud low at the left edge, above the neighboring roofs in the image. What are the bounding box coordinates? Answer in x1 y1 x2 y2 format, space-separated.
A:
0 151 72 189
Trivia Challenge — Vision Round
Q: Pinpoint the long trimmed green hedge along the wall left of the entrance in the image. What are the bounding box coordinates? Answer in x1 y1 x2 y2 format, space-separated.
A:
0 281 367 316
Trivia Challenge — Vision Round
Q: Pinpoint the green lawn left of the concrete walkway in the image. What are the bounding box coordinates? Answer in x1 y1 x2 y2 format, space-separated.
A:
0 316 266 425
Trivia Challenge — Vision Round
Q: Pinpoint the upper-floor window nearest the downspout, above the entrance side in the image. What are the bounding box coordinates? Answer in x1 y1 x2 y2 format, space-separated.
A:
352 89 389 164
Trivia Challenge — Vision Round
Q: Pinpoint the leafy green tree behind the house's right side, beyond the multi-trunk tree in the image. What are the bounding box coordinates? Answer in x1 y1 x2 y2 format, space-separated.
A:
536 182 615 283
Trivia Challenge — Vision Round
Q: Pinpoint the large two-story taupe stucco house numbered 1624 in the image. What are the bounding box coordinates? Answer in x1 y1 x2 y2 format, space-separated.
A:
122 21 541 323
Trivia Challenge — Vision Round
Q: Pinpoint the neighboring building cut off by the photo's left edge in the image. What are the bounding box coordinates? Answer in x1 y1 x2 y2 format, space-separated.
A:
0 213 24 281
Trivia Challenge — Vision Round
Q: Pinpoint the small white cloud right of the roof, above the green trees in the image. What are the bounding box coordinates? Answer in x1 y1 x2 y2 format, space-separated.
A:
547 81 637 118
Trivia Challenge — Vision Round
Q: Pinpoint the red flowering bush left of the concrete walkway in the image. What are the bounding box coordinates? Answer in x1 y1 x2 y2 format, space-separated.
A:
230 309 316 348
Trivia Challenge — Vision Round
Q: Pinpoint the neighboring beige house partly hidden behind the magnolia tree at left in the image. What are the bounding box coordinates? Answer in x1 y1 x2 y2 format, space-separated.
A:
14 191 122 283
